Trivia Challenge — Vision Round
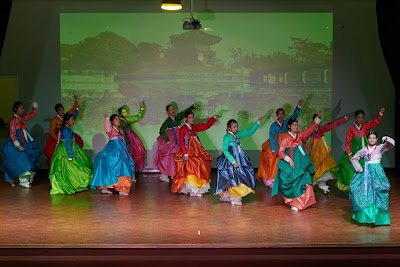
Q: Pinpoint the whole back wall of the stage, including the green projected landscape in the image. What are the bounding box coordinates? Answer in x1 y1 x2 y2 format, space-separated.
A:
0 0 394 168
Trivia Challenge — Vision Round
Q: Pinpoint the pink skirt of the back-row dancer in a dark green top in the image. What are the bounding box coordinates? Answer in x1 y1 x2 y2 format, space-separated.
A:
153 127 179 177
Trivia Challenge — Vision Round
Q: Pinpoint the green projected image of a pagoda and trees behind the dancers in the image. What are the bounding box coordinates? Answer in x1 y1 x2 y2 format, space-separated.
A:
60 13 334 156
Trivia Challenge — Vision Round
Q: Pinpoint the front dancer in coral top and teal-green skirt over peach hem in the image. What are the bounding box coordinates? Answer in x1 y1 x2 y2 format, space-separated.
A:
271 112 321 212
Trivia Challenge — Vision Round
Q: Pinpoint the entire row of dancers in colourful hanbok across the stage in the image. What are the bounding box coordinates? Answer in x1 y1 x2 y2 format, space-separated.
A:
2 95 395 225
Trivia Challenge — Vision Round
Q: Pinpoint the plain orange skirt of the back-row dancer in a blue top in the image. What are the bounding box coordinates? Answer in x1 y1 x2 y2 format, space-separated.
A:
257 135 282 187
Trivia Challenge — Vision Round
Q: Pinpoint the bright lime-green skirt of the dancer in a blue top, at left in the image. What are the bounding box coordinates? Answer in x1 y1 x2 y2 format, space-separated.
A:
49 140 93 195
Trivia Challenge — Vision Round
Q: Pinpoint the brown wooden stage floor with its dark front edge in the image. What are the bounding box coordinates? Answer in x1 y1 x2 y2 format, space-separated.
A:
0 170 400 266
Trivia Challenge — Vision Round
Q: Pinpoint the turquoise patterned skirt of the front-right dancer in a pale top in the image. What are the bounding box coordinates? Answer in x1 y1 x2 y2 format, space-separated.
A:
350 163 390 225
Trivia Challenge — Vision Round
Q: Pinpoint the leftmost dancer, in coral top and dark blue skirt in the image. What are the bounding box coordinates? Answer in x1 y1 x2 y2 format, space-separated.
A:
1 99 42 188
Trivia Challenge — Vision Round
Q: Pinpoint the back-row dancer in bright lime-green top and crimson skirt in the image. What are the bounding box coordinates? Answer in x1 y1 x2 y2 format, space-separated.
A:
118 102 146 172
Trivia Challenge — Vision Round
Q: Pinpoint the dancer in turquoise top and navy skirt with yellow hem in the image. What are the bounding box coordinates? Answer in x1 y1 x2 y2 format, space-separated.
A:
214 117 263 205
